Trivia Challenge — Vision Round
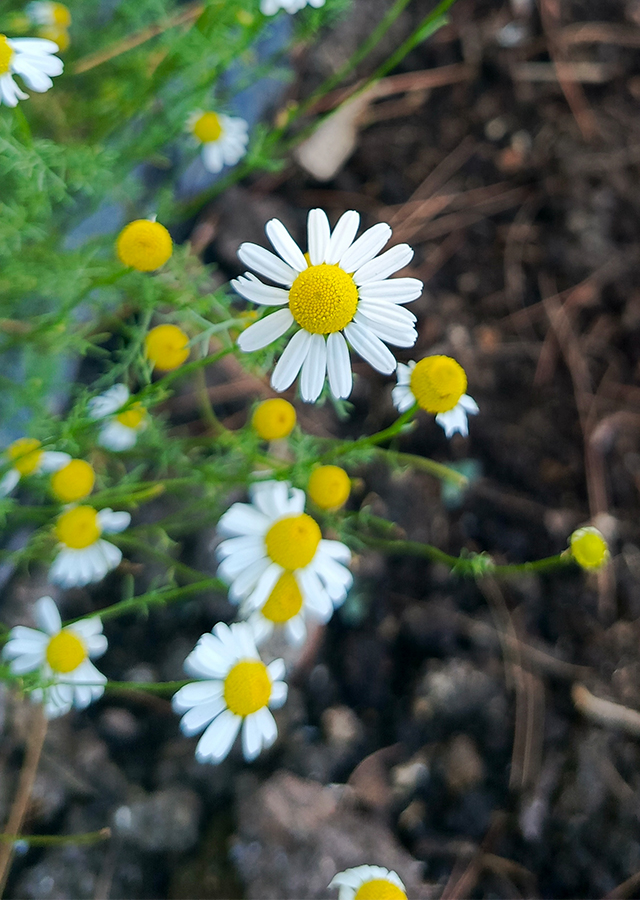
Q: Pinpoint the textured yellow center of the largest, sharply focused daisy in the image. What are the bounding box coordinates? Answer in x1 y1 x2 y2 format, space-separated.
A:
289 263 358 334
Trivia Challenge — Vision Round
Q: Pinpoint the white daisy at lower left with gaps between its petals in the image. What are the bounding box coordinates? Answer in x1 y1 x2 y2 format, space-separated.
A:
2 597 107 719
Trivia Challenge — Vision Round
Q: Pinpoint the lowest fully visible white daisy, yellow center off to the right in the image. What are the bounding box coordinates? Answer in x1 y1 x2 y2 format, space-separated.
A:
172 622 287 763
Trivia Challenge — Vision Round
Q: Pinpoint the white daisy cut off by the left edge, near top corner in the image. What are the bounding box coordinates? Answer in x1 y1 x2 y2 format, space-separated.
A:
0 34 63 106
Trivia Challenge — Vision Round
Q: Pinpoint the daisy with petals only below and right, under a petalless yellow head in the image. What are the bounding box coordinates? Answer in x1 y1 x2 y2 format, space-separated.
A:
49 506 131 588
